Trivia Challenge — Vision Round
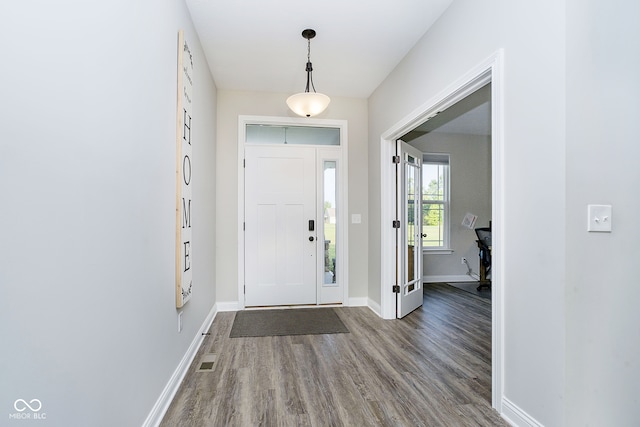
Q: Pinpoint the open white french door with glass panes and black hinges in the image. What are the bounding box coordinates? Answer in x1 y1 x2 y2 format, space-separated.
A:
396 141 423 318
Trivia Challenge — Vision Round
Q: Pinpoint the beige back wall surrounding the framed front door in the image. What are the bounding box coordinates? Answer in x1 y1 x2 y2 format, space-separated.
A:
216 90 368 303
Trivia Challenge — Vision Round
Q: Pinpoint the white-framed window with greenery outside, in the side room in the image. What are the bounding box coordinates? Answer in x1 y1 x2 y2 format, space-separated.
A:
422 153 449 251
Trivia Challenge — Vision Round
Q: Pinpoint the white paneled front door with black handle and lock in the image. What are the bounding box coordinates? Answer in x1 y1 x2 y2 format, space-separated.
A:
244 145 318 306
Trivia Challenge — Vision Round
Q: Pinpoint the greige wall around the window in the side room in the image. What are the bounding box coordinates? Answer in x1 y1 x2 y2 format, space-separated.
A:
411 132 491 280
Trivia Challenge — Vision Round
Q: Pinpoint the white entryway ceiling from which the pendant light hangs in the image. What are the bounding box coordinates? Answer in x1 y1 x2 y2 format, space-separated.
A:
186 0 453 98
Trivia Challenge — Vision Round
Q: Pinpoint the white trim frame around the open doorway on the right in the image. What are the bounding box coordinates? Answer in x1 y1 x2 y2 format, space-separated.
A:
380 50 505 413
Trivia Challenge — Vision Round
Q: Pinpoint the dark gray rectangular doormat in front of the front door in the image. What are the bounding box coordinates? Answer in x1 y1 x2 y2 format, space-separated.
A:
229 308 349 338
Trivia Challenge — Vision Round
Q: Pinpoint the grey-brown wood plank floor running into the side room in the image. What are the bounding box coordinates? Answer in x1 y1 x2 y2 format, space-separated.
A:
161 284 508 427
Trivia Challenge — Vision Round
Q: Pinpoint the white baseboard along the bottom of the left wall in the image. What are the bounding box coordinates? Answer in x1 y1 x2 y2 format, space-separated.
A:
142 304 217 427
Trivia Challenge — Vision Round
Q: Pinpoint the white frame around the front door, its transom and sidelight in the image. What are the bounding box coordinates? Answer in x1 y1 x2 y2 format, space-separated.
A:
237 115 349 310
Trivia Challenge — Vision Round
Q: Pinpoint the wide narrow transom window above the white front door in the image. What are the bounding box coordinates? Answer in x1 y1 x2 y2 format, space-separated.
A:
245 124 340 145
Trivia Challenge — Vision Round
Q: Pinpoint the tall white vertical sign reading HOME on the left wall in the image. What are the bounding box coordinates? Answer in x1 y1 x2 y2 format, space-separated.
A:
176 30 193 308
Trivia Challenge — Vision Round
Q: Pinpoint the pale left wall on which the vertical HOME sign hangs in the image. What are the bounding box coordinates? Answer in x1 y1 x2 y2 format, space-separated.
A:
0 0 216 426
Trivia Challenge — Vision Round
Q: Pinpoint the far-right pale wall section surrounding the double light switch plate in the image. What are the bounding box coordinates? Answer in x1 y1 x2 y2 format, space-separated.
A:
565 0 640 427
